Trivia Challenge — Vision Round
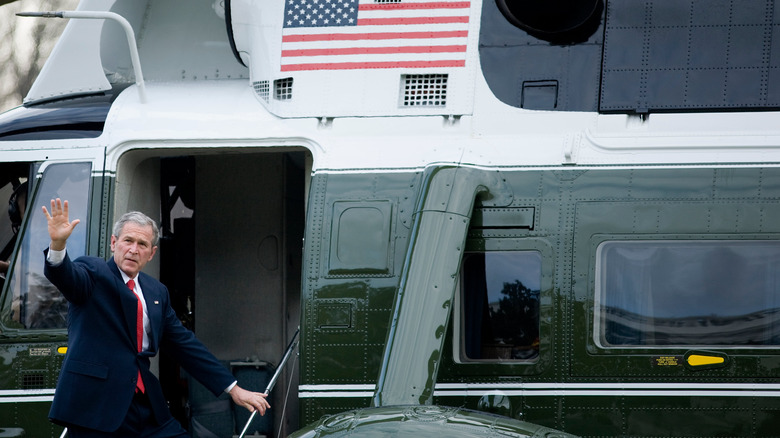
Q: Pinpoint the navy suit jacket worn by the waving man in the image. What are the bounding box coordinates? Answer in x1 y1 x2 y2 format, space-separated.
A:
44 255 235 432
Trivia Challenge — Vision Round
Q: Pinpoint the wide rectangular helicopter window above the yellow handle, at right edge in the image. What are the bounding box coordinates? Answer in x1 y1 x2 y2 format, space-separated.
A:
594 240 780 347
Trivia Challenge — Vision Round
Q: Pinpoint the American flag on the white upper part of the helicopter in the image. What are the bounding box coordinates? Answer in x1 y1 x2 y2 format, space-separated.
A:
281 0 471 71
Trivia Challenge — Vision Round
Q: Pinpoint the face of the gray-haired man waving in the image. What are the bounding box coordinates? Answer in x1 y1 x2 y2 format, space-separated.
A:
111 222 157 278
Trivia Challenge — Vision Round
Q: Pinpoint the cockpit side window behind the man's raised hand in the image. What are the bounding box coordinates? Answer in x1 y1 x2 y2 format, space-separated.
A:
0 163 91 329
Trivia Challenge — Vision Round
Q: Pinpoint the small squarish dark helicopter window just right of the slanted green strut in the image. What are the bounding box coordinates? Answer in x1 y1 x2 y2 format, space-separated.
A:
461 251 542 361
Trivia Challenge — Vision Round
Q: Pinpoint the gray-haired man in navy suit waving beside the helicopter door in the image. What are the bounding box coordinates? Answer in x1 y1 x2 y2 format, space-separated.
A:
43 198 270 438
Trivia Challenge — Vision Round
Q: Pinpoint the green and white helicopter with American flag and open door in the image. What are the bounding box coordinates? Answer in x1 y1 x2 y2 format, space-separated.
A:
0 0 780 438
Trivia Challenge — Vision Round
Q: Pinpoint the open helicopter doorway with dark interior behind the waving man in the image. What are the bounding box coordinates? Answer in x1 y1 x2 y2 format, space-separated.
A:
114 150 310 437
